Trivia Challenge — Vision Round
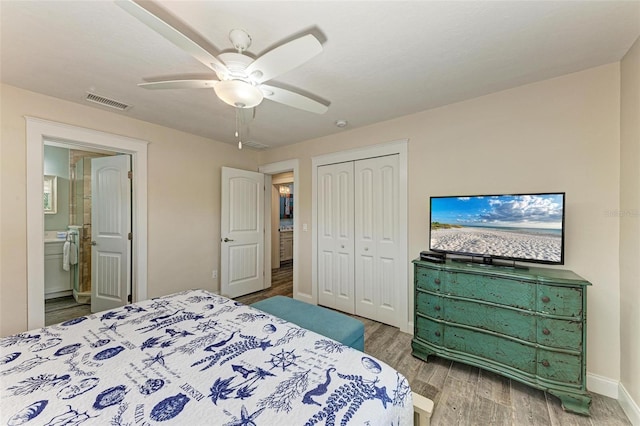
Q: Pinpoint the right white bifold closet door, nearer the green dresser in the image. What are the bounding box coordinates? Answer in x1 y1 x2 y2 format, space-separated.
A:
355 155 406 325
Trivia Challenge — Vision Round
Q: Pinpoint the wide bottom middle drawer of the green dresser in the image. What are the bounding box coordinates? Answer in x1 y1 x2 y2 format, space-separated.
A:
444 326 536 375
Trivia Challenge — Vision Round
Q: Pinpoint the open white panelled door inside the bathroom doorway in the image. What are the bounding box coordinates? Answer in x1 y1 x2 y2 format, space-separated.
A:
91 155 131 312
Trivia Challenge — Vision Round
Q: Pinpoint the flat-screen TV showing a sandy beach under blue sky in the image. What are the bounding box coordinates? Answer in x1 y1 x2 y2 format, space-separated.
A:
430 194 563 263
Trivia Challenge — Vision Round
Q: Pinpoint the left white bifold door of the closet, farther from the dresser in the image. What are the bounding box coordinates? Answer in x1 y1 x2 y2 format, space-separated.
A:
317 162 354 314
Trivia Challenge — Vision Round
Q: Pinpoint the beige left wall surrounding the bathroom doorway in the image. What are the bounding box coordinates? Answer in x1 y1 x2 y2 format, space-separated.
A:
0 85 258 336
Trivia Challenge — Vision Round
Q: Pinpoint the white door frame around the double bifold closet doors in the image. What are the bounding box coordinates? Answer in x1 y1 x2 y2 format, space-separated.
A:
312 139 413 333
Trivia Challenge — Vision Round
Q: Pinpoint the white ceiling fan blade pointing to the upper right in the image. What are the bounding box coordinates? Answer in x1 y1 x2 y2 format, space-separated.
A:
246 34 322 83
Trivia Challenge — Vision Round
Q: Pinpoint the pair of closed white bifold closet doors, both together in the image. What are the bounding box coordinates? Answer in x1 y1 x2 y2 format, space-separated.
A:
317 155 406 326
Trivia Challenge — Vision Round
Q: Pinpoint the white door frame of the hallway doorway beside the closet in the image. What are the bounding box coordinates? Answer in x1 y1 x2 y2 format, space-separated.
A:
258 158 300 301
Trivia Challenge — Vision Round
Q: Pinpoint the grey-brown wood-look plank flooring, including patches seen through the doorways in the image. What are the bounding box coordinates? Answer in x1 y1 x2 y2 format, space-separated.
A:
46 263 631 426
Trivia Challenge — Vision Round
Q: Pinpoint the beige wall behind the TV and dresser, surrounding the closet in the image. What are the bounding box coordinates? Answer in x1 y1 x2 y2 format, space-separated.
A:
262 64 620 380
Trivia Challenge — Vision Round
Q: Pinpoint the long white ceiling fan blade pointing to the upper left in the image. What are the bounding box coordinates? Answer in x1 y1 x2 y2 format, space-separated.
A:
116 0 228 74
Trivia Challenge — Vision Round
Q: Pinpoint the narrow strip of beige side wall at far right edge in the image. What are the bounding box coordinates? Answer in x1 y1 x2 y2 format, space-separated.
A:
620 38 640 410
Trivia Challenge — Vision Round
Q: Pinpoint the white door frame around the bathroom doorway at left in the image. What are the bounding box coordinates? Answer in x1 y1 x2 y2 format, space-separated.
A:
25 116 148 330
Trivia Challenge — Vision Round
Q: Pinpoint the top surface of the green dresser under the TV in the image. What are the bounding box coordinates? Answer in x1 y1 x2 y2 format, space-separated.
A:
413 259 591 286
